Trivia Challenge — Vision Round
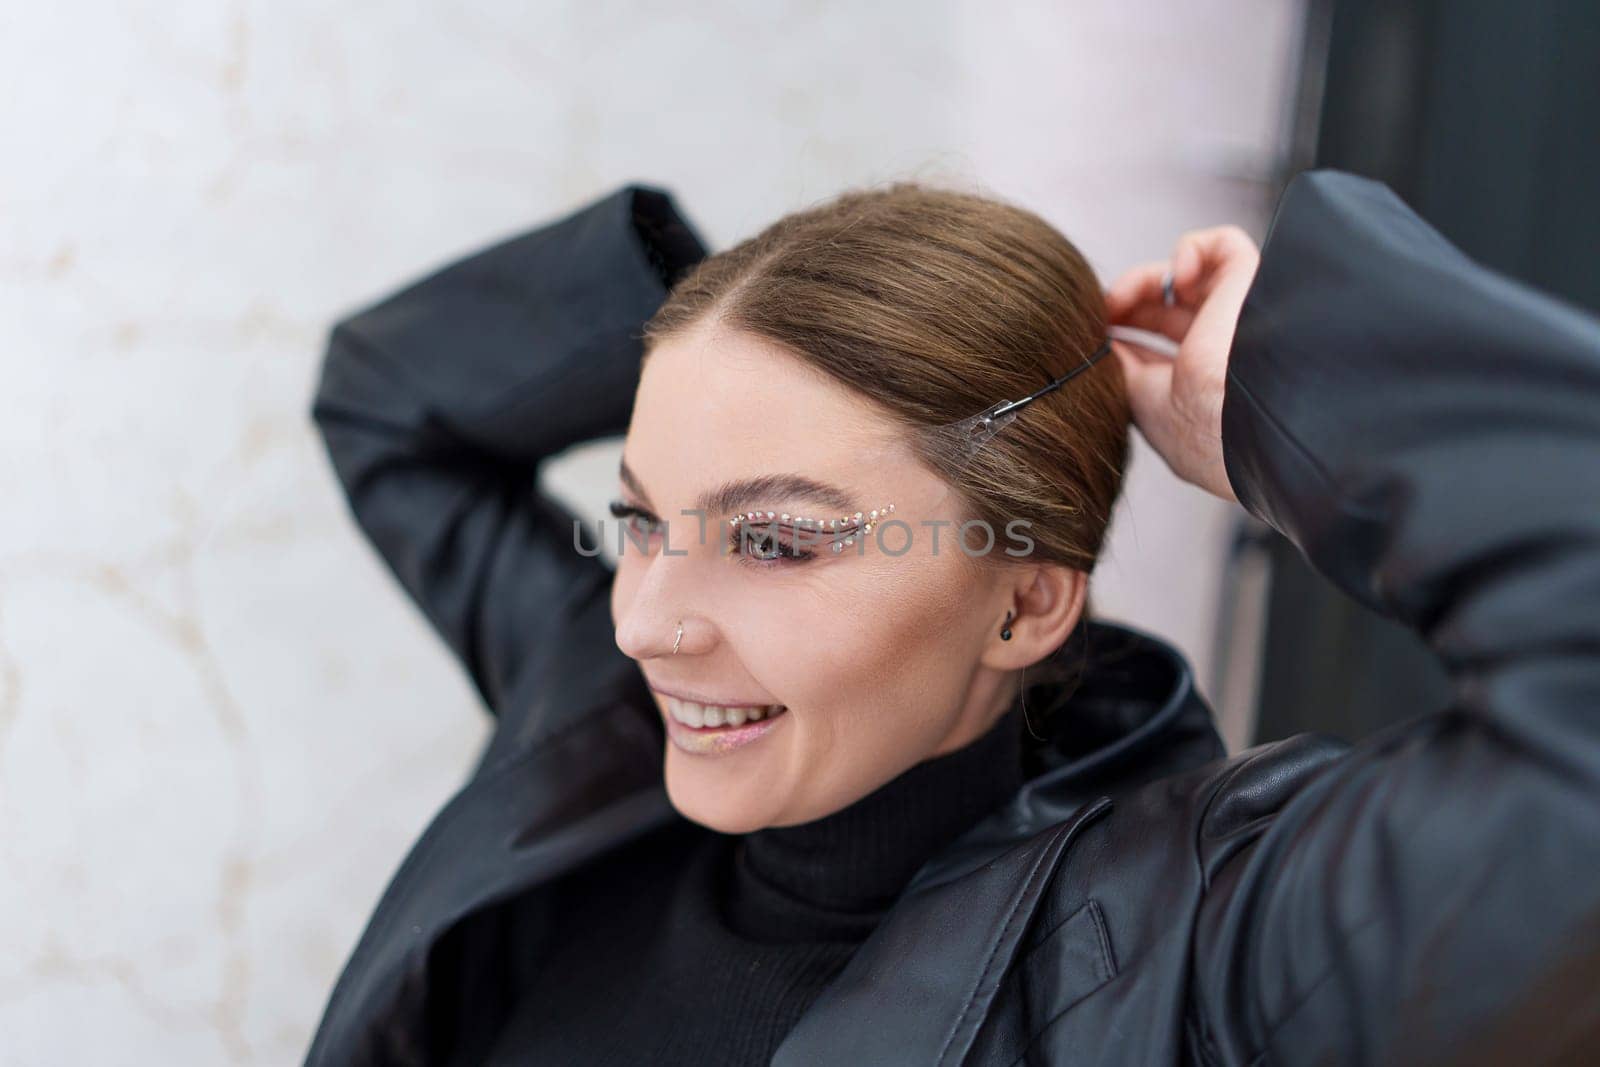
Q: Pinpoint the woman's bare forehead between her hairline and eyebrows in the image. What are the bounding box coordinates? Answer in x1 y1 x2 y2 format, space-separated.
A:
626 316 920 507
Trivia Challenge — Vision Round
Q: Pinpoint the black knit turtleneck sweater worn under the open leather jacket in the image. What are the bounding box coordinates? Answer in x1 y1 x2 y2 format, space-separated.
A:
486 707 1022 1067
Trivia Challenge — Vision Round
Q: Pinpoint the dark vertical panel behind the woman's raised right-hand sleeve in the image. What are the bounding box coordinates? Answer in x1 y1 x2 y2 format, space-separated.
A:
1256 0 1600 741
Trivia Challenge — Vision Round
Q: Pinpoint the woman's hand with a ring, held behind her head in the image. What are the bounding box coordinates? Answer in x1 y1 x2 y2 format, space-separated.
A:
1106 226 1261 504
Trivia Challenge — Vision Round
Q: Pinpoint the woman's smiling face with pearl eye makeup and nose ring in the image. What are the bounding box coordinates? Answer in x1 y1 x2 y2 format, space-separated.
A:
606 316 1014 833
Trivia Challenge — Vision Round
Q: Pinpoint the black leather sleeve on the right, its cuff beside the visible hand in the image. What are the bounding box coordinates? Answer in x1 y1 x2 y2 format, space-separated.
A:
1190 171 1600 1064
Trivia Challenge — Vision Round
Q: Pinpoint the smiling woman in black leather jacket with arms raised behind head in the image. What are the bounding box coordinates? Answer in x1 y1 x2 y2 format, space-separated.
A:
309 173 1600 1064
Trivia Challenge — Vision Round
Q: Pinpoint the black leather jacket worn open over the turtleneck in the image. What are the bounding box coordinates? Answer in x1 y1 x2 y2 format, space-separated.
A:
307 171 1600 1067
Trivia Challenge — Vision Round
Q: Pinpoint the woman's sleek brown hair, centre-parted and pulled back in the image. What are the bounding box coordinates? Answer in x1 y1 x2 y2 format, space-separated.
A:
645 181 1128 585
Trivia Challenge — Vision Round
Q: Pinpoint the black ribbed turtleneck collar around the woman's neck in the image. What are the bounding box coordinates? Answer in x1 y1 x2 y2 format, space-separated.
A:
728 705 1024 941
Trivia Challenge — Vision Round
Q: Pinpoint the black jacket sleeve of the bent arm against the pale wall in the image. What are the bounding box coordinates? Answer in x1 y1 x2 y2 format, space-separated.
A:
312 186 706 713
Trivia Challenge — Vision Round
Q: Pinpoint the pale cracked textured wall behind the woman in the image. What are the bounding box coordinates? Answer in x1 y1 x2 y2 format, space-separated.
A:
0 0 1294 1064
